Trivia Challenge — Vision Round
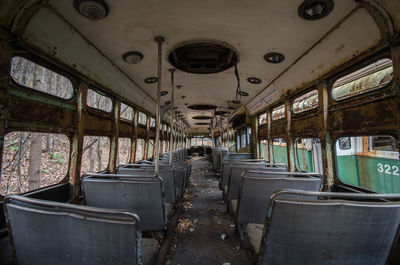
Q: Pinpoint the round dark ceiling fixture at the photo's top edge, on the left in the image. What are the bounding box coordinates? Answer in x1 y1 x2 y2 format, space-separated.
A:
74 0 110 20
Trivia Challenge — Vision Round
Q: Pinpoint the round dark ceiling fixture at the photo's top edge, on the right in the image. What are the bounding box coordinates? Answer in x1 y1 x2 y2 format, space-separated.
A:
298 0 335 20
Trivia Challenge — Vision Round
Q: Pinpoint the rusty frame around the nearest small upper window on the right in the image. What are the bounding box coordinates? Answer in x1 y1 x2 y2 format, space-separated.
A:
329 54 395 103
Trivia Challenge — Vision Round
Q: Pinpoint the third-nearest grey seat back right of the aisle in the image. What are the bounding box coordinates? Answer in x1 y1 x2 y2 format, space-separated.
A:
226 163 287 201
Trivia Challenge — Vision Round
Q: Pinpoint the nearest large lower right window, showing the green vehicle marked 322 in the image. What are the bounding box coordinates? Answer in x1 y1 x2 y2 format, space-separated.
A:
335 136 400 193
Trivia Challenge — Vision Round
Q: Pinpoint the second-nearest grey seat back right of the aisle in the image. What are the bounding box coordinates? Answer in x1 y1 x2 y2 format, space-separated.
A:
236 173 322 226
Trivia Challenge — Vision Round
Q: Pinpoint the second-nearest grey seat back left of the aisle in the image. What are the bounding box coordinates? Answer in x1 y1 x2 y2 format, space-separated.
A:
82 174 166 231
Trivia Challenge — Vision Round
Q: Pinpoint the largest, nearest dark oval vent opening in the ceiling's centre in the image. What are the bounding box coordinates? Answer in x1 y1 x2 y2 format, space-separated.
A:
169 42 238 74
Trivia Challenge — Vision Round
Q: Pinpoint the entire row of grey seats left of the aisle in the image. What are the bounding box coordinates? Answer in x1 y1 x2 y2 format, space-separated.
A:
5 147 191 265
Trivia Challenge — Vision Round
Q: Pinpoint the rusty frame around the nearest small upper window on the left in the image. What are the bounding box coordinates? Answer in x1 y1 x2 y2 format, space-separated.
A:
8 53 78 102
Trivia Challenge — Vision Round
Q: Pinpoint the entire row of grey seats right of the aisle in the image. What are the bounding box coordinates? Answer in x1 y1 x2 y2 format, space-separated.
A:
214 148 400 265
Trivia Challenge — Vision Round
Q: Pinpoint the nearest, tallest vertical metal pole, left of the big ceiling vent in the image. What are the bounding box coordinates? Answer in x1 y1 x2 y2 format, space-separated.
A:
154 36 164 176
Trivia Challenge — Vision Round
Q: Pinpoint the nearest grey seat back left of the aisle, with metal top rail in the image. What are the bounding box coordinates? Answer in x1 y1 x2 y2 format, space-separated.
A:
5 195 142 265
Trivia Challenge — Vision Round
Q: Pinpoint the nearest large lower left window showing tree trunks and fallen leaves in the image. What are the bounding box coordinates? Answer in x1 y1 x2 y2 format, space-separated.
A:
0 132 70 195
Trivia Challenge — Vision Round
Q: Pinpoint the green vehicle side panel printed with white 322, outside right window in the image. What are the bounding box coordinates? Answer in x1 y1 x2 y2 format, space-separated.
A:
357 156 400 193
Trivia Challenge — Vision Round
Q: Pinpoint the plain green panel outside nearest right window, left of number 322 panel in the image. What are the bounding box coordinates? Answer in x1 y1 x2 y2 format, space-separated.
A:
336 155 360 186
